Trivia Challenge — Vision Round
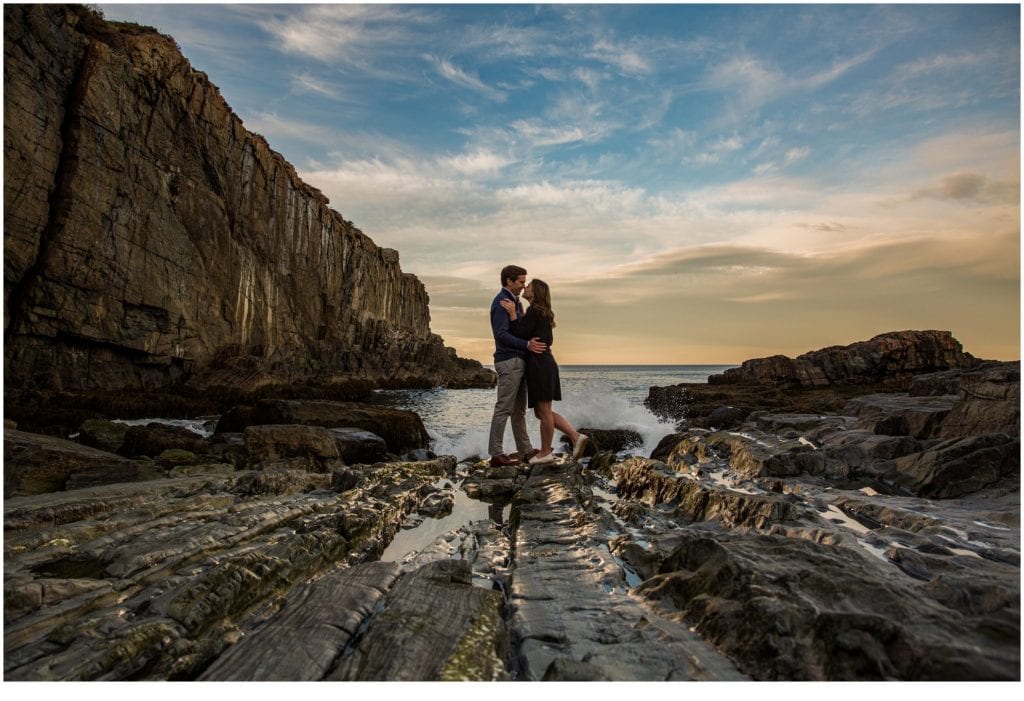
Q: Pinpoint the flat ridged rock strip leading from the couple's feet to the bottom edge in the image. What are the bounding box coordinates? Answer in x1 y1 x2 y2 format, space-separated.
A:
510 464 743 682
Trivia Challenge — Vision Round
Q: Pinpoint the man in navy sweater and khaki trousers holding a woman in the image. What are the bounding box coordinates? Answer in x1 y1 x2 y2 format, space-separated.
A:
487 265 548 468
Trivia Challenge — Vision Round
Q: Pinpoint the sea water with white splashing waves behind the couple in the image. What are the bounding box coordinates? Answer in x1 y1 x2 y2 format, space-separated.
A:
374 365 735 461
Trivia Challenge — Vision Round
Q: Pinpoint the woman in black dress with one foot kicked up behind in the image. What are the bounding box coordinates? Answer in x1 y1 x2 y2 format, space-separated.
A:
501 279 588 465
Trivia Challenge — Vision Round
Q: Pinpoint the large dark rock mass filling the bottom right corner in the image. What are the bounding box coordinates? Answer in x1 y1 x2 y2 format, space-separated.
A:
638 529 1019 681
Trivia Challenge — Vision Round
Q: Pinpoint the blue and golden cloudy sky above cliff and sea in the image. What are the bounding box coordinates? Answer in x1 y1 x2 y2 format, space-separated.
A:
98 4 1021 364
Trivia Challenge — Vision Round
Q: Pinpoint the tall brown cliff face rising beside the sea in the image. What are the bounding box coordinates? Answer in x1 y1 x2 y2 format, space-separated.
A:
4 5 487 390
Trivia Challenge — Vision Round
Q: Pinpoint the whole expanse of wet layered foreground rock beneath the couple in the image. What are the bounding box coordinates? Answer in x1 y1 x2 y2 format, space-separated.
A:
4 343 1020 681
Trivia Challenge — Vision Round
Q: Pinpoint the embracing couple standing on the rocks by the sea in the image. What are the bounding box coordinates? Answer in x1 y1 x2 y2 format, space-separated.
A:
487 265 588 467
